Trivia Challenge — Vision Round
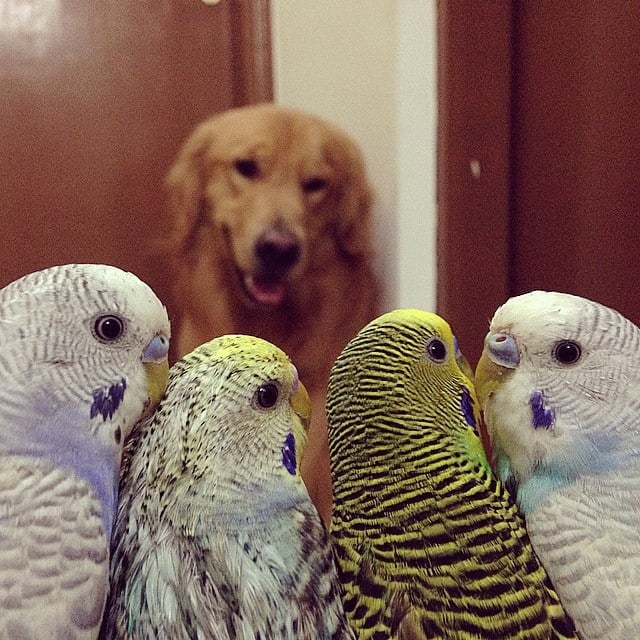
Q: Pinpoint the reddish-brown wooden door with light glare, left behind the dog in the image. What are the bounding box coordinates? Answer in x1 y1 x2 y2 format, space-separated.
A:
0 0 272 310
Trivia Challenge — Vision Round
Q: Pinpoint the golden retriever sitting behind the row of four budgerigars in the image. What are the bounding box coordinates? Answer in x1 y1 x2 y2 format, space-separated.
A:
166 103 379 521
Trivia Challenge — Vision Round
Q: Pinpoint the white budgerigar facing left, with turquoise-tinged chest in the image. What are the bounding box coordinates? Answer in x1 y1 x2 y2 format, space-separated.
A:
477 291 640 640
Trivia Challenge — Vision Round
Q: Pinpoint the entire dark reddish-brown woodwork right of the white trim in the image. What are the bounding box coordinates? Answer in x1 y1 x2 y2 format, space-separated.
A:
439 0 640 362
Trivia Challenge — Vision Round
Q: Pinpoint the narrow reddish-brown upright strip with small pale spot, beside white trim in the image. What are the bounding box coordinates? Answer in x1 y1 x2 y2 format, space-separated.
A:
437 0 511 363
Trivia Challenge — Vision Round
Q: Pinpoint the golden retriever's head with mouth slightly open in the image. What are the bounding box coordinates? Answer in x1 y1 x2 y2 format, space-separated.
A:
167 104 372 307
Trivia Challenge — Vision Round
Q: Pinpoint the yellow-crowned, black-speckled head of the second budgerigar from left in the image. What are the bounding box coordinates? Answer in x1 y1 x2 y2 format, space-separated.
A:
139 335 310 502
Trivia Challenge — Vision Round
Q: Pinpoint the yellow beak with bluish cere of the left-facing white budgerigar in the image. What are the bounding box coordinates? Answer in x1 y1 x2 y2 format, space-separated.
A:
475 333 520 407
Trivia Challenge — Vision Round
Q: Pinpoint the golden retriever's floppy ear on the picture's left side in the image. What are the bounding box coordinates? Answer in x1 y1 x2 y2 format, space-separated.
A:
165 116 217 254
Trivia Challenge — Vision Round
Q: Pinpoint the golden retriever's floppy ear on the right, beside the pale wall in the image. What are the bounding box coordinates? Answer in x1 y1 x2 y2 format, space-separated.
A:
336 140 374 259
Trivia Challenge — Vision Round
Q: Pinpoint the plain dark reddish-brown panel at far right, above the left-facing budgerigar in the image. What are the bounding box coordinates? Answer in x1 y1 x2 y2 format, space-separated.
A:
512 1 640 314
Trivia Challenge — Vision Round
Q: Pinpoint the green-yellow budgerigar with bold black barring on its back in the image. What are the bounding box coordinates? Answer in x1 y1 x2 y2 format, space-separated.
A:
327 309 575 640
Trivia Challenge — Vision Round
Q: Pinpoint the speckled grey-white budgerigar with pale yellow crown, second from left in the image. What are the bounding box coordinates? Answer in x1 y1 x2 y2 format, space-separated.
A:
102 335 352 640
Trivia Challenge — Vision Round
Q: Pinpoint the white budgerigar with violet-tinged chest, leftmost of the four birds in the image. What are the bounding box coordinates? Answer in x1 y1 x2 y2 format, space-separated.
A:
0 264 169 640
